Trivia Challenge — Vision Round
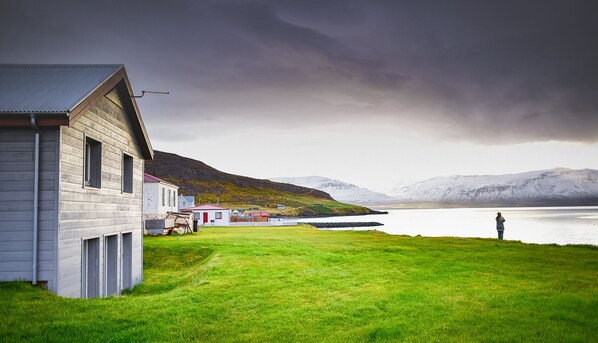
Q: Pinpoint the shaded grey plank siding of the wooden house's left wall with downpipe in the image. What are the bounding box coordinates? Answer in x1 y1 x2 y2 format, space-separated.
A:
0 129 58 291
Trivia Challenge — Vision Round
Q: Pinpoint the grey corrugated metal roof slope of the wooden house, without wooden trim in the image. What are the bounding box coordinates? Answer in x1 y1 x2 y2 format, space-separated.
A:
0 64 122 113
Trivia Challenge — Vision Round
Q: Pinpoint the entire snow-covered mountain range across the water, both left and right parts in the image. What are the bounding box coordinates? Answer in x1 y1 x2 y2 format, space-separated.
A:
272 168 598 207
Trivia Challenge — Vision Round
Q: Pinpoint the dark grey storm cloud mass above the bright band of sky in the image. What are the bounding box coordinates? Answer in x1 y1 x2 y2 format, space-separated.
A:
0 0 598 143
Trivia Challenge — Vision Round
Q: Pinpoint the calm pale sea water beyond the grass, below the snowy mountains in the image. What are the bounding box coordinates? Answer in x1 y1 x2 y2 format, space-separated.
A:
299 206 598 245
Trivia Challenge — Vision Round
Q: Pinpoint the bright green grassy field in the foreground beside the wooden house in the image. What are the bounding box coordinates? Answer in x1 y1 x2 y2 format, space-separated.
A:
0 226 598 342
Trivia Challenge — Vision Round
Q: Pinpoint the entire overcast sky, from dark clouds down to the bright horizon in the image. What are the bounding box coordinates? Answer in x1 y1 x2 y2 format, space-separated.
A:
0 0 598 189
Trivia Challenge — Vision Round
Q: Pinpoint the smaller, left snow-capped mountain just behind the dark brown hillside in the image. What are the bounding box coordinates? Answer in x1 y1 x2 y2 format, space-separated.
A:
270 176 393 205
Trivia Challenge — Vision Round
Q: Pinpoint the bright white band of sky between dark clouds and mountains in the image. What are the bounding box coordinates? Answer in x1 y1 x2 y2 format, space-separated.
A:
154 123 598 191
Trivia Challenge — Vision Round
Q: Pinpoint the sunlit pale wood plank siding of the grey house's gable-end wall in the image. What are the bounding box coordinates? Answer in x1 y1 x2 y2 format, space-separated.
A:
58 97 143 297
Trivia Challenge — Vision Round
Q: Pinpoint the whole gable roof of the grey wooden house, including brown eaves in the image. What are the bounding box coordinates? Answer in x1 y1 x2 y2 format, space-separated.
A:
0 64 154 159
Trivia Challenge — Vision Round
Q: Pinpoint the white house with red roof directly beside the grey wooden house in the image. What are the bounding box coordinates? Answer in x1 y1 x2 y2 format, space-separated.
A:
143 173 179 219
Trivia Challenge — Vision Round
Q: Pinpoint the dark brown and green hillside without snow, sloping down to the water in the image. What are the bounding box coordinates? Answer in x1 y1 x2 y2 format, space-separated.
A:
145 151 375 216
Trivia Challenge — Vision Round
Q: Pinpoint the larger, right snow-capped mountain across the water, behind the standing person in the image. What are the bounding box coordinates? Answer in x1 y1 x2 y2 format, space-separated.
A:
393 168 598 204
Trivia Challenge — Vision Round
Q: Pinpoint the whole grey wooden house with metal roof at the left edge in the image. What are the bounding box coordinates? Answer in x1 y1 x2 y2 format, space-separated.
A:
0 65 153 298
